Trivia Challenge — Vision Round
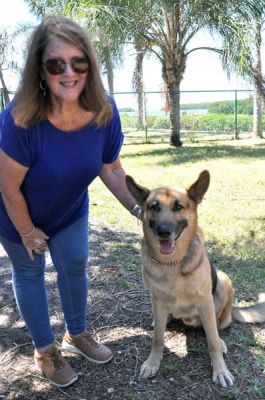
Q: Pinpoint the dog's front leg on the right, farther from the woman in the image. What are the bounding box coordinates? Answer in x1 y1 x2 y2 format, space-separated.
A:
199 297 234 388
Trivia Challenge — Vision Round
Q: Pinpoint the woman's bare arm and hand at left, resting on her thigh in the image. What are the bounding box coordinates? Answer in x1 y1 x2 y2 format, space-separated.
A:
0 150 48 259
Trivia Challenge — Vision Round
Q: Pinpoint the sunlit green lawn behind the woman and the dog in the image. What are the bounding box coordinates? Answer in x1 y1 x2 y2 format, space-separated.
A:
90 139 265 302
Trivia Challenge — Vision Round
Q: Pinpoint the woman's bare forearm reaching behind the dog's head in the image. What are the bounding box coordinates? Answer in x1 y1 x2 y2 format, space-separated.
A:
99 159 140 217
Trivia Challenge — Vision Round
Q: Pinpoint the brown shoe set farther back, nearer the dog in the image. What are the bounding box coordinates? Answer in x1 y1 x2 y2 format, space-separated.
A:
62 331 113 364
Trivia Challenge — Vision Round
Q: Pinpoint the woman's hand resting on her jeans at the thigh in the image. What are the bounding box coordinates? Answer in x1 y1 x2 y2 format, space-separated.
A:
21 227 49 260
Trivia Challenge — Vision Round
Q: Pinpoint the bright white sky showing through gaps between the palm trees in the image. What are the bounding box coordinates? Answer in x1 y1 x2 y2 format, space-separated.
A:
0 0 252 107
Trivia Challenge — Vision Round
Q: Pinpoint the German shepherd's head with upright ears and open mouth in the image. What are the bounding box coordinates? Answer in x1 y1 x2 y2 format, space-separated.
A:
126 170 210 259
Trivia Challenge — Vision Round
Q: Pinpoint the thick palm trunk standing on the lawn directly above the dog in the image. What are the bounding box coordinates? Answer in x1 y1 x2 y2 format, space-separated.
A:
168 83 182 147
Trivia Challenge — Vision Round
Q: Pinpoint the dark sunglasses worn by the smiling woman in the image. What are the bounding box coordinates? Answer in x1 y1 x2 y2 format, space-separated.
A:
42 57 89 75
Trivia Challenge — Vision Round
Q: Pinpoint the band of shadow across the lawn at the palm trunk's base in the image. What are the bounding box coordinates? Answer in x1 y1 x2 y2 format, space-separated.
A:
124 142 265 166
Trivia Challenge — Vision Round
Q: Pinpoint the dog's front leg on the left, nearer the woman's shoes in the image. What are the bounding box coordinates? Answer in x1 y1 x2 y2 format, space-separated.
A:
140 299 168 379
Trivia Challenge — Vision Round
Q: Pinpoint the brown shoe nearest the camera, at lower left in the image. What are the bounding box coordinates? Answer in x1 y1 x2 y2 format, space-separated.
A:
34 346 78 387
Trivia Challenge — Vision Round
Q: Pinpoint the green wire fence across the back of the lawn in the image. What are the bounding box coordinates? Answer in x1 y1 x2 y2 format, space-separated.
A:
0 89 260 143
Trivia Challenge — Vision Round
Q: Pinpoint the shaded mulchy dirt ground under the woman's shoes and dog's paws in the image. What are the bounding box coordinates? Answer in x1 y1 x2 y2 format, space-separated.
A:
0 220 265 400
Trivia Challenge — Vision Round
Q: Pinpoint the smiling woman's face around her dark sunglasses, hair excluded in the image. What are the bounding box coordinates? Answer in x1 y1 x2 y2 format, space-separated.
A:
42 38 88 103
